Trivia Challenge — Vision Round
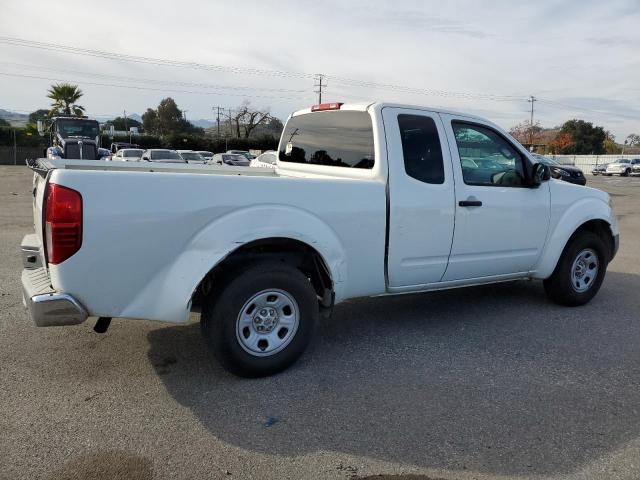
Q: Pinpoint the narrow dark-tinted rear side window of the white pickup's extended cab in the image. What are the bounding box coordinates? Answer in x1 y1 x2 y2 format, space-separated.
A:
398 115 444 183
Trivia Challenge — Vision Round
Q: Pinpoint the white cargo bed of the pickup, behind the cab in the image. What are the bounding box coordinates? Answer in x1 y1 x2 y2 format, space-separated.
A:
29 159 386 323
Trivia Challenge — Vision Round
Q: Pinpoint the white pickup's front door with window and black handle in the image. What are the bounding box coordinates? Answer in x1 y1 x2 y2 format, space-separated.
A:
442 115 550 281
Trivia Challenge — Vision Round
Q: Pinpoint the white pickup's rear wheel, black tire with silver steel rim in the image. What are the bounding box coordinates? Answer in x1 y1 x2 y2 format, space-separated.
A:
200 262 318 377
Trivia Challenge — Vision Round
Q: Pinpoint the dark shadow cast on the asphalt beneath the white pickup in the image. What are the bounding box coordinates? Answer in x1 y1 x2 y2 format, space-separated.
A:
148 272 640 476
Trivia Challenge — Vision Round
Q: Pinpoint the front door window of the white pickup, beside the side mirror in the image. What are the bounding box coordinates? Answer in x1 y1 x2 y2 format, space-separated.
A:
451 122 526 187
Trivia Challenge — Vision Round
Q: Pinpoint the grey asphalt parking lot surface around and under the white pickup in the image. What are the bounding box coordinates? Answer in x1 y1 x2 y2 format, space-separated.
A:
0 167 640 480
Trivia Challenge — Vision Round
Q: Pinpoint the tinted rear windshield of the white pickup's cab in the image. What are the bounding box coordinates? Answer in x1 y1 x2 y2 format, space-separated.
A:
278 111 374 169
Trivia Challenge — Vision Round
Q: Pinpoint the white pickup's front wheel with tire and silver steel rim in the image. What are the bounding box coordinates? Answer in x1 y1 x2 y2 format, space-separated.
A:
544 232 609 306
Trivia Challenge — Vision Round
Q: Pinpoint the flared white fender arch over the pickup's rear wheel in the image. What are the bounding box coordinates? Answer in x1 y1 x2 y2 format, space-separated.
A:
117 204 347 322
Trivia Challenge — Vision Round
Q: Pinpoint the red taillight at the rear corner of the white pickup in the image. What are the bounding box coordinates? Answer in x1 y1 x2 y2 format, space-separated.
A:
44 183 82 264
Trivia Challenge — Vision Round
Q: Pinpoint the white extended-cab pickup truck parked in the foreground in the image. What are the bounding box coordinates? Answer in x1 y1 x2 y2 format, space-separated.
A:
22 103 619 376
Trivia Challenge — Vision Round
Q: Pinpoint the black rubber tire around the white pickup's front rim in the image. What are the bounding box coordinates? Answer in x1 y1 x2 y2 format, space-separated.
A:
544 231 609 307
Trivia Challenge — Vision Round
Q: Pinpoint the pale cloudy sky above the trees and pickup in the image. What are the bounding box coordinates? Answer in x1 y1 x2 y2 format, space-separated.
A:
0 0 640 142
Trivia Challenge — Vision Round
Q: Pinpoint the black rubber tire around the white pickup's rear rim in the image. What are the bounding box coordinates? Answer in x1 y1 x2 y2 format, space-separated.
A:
200 261 319 377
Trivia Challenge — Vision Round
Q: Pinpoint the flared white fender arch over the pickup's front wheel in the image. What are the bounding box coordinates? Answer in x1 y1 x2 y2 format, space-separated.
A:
532 197 618 279
